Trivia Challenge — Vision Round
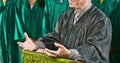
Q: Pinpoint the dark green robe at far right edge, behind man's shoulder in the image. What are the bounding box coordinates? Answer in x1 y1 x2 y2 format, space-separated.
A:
110 0 120 63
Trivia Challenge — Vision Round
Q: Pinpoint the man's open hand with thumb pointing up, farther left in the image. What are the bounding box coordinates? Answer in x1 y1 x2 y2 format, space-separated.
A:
17 32 37 51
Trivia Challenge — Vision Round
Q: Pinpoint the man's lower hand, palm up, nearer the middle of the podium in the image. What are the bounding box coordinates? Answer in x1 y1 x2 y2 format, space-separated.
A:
44 43 71 58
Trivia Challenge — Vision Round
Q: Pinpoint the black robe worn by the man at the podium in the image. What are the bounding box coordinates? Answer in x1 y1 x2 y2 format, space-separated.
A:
38 5 112 63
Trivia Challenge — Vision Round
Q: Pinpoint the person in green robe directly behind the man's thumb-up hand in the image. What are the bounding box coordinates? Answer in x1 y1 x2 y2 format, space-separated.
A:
14 0 44 63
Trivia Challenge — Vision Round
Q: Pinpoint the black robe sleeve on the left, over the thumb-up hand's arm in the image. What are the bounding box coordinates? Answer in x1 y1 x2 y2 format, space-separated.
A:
37 13 65 50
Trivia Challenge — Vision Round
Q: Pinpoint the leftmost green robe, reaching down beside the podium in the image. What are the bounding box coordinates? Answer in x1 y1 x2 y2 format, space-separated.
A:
0 0 19 63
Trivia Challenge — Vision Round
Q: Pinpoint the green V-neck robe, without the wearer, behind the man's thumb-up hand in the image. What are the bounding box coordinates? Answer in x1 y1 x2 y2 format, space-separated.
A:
15 0 43 40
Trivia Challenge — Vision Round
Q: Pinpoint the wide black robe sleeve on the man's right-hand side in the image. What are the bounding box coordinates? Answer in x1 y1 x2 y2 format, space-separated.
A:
77 16 112 63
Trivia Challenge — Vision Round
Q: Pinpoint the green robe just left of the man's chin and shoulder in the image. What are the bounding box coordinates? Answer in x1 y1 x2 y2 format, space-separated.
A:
43 0 69 35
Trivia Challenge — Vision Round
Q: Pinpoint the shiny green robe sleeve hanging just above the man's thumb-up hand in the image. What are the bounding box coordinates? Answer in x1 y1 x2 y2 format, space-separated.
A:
14 0 26 40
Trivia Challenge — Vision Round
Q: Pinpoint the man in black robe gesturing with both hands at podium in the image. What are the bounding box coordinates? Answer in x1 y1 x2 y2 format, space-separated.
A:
18 0 112 63
